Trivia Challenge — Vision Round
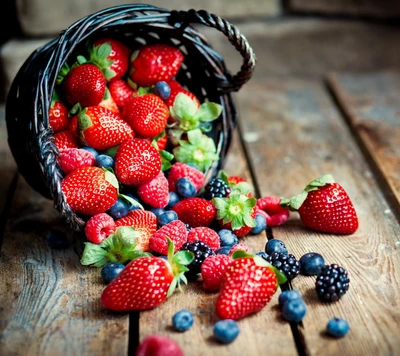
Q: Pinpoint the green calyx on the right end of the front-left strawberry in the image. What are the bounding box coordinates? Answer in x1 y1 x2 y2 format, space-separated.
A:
167 237 194 297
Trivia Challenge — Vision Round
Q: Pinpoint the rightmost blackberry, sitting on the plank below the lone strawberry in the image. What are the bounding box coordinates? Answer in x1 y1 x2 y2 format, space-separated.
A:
315 264 350 302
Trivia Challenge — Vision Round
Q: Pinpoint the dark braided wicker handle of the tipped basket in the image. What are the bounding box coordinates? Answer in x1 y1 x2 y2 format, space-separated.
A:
171 9 257 92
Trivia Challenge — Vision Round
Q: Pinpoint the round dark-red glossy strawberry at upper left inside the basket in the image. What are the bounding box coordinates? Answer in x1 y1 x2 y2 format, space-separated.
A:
63 63 106 108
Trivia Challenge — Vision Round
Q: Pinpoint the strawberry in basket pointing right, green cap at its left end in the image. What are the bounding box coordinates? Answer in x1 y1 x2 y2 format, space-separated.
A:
79 106 134 150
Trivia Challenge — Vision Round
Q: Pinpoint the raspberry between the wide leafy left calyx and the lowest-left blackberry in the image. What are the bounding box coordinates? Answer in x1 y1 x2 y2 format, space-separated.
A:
150 220 187 255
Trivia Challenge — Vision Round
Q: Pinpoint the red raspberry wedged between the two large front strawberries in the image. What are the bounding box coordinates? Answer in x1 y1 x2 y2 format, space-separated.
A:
201 255 233 291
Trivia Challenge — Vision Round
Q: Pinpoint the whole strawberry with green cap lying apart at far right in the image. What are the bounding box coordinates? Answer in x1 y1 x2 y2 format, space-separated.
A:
281 174 358 235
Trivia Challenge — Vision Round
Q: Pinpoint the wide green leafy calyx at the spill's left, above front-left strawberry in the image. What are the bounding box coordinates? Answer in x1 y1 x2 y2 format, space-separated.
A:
81 226 151 267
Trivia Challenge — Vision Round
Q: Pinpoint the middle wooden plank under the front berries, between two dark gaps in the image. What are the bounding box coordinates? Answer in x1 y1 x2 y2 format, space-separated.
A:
139 129 296 356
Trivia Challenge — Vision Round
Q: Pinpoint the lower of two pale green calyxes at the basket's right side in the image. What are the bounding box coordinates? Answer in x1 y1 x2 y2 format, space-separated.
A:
173 129 219 172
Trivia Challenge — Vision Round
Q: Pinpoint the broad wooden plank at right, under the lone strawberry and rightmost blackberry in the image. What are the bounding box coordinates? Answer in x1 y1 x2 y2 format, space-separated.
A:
239 79 400 355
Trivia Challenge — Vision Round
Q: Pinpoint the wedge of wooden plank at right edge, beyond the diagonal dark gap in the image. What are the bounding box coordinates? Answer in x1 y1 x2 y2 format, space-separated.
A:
328 72 400 212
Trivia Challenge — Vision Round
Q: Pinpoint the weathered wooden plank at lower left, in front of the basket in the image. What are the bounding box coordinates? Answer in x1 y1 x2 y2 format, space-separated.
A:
0 178 128 356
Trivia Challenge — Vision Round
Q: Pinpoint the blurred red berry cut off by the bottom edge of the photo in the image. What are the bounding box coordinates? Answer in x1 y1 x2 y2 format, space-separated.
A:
135 335 184 356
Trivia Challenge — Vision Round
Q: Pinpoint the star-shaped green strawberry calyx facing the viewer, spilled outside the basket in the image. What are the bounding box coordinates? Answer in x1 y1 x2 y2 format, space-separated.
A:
212 189 257 230
